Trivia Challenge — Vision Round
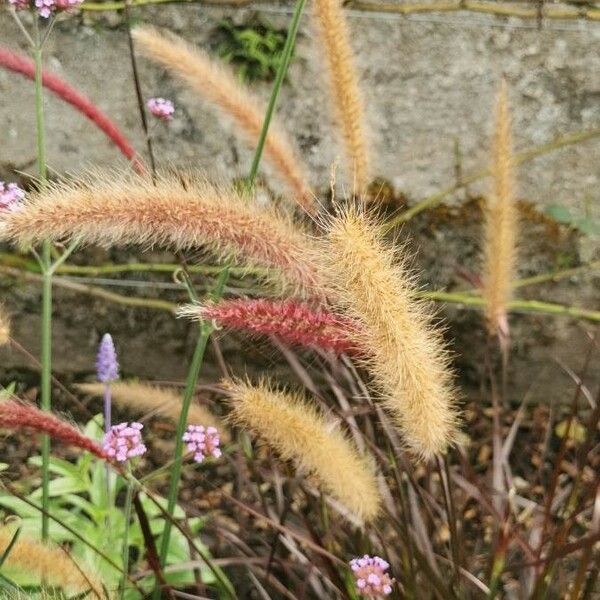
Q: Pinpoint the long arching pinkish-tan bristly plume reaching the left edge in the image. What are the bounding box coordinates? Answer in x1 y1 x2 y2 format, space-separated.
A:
0 173 320 296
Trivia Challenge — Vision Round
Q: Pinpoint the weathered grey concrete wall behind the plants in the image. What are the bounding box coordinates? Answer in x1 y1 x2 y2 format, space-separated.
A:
0 5 600 213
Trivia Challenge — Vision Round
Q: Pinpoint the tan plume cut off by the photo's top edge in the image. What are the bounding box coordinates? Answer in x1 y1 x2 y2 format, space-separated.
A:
313 0 370 194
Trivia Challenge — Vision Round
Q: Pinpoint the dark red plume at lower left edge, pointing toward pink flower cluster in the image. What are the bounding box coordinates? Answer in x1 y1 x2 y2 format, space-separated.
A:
0 400 110 460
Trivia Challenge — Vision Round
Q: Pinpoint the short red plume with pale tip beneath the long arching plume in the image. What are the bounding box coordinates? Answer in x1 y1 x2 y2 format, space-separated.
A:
197 300 358 354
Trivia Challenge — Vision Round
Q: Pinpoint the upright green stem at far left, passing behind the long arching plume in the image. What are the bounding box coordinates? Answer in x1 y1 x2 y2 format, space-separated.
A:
33 17 52 540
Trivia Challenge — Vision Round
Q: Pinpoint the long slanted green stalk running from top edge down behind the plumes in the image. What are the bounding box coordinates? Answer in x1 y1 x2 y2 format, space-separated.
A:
153 0 306 600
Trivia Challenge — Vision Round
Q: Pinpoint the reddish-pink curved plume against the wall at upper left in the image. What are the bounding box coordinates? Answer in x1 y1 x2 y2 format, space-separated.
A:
0 47 144 173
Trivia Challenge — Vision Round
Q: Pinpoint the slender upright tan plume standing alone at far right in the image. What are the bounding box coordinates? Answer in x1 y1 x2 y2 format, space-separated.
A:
482 79 519 339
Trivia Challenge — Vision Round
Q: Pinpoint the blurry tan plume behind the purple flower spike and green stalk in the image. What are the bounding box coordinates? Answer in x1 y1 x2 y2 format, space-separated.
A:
75 381 229 441
